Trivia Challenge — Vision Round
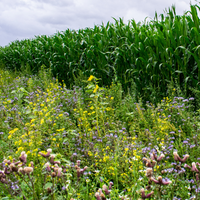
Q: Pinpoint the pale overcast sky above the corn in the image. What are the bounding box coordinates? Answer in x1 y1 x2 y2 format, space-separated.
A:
0 0 197 46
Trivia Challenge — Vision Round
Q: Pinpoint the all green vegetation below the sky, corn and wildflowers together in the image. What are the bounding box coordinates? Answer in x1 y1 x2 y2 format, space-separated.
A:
0 1 200 200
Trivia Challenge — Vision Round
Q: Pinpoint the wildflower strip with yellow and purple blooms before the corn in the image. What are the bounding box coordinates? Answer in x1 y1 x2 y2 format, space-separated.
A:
0 66 200 200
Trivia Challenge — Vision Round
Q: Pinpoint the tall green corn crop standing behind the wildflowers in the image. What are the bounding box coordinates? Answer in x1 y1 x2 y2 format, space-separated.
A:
0 4 200 102
